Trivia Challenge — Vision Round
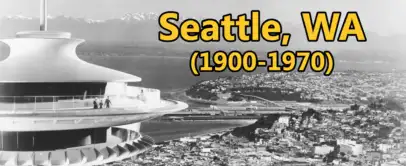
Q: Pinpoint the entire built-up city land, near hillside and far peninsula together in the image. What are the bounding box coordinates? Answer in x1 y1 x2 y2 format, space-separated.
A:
107 71 406 166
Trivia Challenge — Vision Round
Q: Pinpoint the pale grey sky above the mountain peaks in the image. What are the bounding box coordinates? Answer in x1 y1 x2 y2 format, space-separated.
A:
0 0 406 36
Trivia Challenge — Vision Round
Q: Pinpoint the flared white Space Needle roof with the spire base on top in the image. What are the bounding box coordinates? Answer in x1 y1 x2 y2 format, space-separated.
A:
0 1 141 83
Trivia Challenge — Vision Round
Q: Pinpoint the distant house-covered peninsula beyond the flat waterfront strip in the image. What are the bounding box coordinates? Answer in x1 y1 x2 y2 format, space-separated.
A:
192 71 406 103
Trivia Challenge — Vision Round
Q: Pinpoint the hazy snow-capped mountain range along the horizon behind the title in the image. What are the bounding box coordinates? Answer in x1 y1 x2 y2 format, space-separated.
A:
0 12 403 56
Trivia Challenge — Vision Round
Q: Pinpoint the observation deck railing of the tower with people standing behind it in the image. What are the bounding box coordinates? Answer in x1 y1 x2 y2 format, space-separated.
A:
0 95 174 113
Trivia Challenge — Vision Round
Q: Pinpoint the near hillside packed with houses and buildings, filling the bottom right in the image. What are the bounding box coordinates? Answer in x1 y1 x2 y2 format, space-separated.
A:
108 101 406 166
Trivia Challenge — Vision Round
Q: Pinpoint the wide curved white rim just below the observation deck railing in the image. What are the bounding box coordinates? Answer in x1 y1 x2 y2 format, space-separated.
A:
0 101 188 131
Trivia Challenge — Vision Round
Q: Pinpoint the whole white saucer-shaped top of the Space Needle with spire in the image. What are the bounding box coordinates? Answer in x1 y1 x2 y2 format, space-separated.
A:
0 0 188 165
